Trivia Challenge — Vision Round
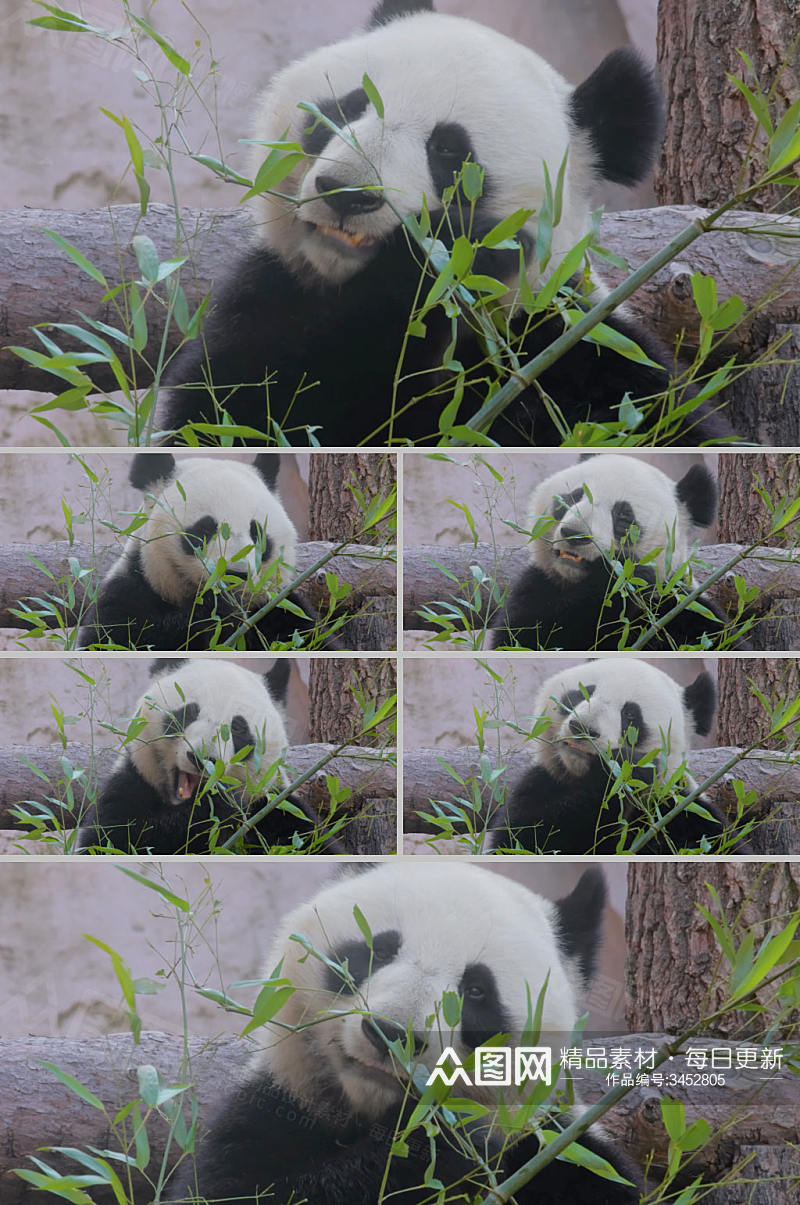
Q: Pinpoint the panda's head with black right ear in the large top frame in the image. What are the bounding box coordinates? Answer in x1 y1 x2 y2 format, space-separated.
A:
253 0 660 282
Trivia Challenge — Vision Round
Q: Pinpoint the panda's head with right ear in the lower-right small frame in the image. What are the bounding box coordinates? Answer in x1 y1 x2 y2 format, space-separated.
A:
534 657 717 777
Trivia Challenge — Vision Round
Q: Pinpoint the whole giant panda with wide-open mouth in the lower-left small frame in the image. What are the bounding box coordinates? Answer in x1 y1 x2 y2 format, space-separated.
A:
76 658 345 853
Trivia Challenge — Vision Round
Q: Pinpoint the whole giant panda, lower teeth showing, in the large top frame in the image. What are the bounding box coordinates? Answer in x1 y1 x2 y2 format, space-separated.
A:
159 0 730 446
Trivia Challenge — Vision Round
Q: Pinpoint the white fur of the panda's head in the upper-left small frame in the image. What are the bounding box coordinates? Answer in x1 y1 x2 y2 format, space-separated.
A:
106 457 298 606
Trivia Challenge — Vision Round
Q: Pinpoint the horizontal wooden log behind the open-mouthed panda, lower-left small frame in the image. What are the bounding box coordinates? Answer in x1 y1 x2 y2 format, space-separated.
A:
0 741 398 828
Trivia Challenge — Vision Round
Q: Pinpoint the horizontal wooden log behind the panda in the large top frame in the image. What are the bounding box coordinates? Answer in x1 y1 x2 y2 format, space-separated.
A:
0 204 800 393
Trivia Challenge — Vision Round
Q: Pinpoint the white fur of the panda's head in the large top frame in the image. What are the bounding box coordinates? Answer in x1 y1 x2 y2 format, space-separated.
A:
252 12 599 283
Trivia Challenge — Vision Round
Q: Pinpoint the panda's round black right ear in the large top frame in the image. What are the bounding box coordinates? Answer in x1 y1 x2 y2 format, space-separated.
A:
570 46 663 184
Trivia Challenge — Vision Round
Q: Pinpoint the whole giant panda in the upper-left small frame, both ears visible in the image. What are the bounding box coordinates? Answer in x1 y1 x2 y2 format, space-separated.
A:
78 452 339 652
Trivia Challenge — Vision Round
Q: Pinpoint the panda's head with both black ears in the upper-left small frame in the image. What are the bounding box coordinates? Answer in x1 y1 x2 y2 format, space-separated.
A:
128 452 298 605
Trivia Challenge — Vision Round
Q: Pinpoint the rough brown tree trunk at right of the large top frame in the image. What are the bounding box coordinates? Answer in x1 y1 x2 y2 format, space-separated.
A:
654 0 800 447
